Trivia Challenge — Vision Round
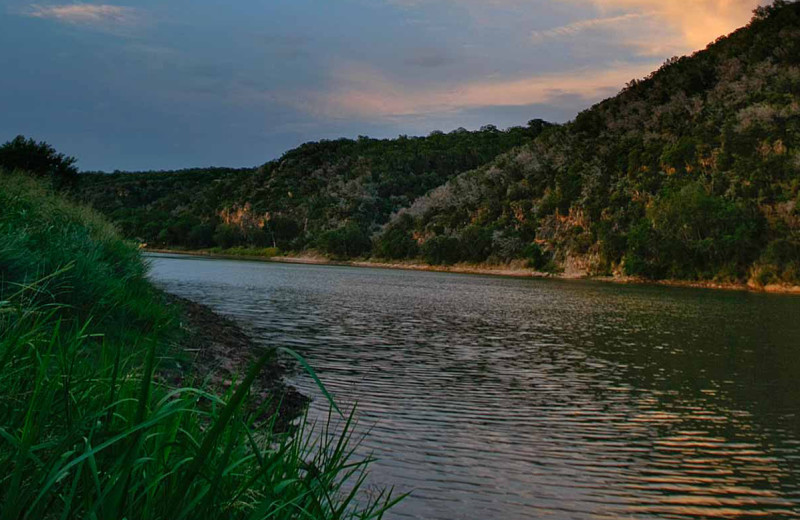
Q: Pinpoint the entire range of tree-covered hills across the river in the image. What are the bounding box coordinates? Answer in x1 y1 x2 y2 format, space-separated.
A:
67 0 800 285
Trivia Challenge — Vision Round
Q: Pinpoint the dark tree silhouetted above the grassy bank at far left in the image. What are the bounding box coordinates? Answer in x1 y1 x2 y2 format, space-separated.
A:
0 135 78 187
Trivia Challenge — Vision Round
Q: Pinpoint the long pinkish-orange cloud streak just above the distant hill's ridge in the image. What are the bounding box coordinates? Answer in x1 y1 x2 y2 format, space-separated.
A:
304 63 658 118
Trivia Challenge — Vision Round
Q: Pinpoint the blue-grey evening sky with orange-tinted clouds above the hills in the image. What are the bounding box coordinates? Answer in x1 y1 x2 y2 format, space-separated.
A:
0 0 759 171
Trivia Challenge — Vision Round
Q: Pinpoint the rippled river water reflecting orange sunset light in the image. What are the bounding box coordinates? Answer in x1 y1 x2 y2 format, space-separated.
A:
145 256 800 520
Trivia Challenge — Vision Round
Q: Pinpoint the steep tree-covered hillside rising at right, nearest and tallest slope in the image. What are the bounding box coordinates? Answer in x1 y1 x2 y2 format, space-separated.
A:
377 2 800 283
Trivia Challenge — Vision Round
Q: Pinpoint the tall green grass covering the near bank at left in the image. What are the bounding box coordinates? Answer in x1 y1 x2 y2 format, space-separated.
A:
0 172 398 520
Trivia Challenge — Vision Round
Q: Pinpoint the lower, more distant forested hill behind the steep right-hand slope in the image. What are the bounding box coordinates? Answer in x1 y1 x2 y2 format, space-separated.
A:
78 120 550 256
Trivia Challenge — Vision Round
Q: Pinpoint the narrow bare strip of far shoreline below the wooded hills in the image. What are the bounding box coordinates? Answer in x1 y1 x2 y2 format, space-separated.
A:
143 248 800 295
